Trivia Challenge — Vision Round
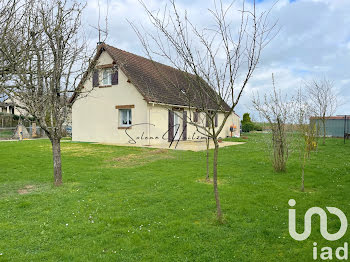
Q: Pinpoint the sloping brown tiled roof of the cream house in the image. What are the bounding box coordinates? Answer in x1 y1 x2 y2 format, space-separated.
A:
99 44 230 111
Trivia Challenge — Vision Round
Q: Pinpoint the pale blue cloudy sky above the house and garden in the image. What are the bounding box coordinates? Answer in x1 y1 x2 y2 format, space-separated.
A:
83 0 350 120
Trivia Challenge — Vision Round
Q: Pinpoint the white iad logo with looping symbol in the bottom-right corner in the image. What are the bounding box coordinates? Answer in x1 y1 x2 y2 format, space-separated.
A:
288 199 348 260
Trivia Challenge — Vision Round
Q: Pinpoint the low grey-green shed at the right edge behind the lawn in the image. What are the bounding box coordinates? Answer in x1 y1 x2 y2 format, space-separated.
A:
310 115 350 137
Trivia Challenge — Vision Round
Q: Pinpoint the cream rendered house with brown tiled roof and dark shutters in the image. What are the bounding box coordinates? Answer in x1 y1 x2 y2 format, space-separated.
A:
71 43 240 145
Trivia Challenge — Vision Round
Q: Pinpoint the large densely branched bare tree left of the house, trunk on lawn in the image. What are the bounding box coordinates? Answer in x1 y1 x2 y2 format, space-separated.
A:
0 0 86 186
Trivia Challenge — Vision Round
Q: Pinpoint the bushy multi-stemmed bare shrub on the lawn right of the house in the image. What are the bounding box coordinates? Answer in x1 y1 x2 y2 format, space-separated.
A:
252 74 293 172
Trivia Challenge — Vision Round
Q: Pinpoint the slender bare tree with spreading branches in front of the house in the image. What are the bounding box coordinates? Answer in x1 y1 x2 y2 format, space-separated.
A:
131 0 274 221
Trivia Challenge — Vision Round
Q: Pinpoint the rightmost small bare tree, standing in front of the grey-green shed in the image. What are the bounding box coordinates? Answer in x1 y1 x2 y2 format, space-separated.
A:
305 78 338 145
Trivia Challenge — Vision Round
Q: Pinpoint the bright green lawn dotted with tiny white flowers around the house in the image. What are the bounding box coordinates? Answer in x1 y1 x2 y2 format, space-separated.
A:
0 134 350 261
